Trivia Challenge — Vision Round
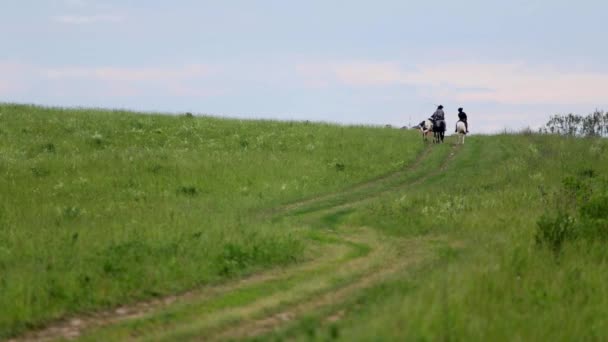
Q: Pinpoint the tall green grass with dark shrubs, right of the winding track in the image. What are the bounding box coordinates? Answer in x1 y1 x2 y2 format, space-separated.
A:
276 134 608 341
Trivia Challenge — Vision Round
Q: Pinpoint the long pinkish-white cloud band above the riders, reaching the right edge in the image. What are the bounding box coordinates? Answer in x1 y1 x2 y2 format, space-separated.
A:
296 62 608 104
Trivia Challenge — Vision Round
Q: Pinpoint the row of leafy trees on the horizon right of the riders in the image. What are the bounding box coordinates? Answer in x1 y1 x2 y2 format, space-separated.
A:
540 109 608 137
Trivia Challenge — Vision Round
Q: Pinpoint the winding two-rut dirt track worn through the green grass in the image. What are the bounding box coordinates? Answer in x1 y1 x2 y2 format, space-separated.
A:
12 146 459 341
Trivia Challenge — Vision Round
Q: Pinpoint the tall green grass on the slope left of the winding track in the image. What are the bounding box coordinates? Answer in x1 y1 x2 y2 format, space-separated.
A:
0 104 422 337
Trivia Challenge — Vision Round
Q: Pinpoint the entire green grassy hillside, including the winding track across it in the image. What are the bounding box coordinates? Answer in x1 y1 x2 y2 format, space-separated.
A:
0 104 608 341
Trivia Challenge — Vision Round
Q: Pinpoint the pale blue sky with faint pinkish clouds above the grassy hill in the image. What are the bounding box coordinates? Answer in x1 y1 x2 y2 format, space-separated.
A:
0 0 608 133
